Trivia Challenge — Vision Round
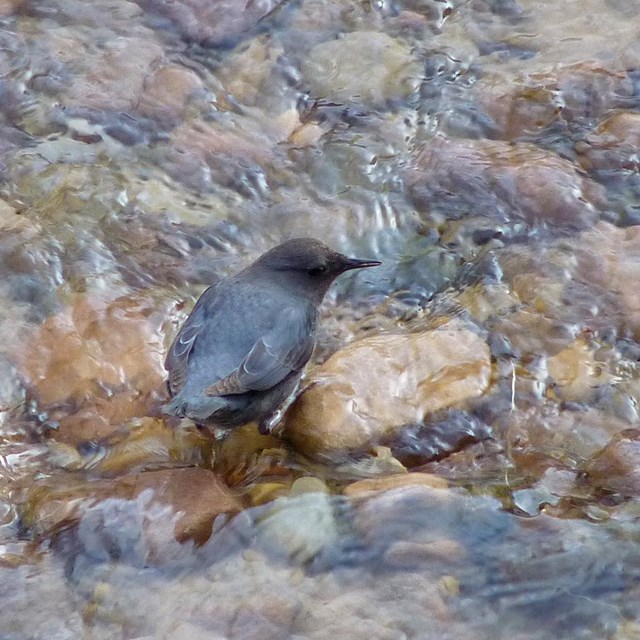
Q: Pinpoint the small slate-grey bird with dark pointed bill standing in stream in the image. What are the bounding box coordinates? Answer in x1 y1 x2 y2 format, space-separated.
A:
162 238 381 434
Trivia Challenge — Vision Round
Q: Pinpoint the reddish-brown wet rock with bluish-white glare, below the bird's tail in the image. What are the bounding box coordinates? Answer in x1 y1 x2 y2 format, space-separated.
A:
23 467 243 548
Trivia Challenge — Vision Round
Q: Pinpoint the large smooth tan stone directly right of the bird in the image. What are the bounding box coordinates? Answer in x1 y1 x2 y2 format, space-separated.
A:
284 324 491 456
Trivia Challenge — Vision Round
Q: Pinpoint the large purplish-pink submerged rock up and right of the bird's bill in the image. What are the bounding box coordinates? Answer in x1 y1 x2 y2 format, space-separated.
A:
406 138 604 230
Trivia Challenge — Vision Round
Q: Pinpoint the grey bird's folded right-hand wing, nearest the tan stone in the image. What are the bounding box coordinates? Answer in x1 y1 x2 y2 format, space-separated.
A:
205 304 316 396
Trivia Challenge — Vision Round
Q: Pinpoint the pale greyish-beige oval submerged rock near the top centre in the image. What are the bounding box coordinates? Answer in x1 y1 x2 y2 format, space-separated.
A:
302 31 423 107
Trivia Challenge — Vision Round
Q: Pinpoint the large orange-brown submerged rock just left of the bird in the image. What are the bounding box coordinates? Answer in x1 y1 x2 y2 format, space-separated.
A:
14 294 168 441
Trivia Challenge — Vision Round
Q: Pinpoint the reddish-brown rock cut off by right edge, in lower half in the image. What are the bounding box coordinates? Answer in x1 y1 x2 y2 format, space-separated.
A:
582 429 640 496
